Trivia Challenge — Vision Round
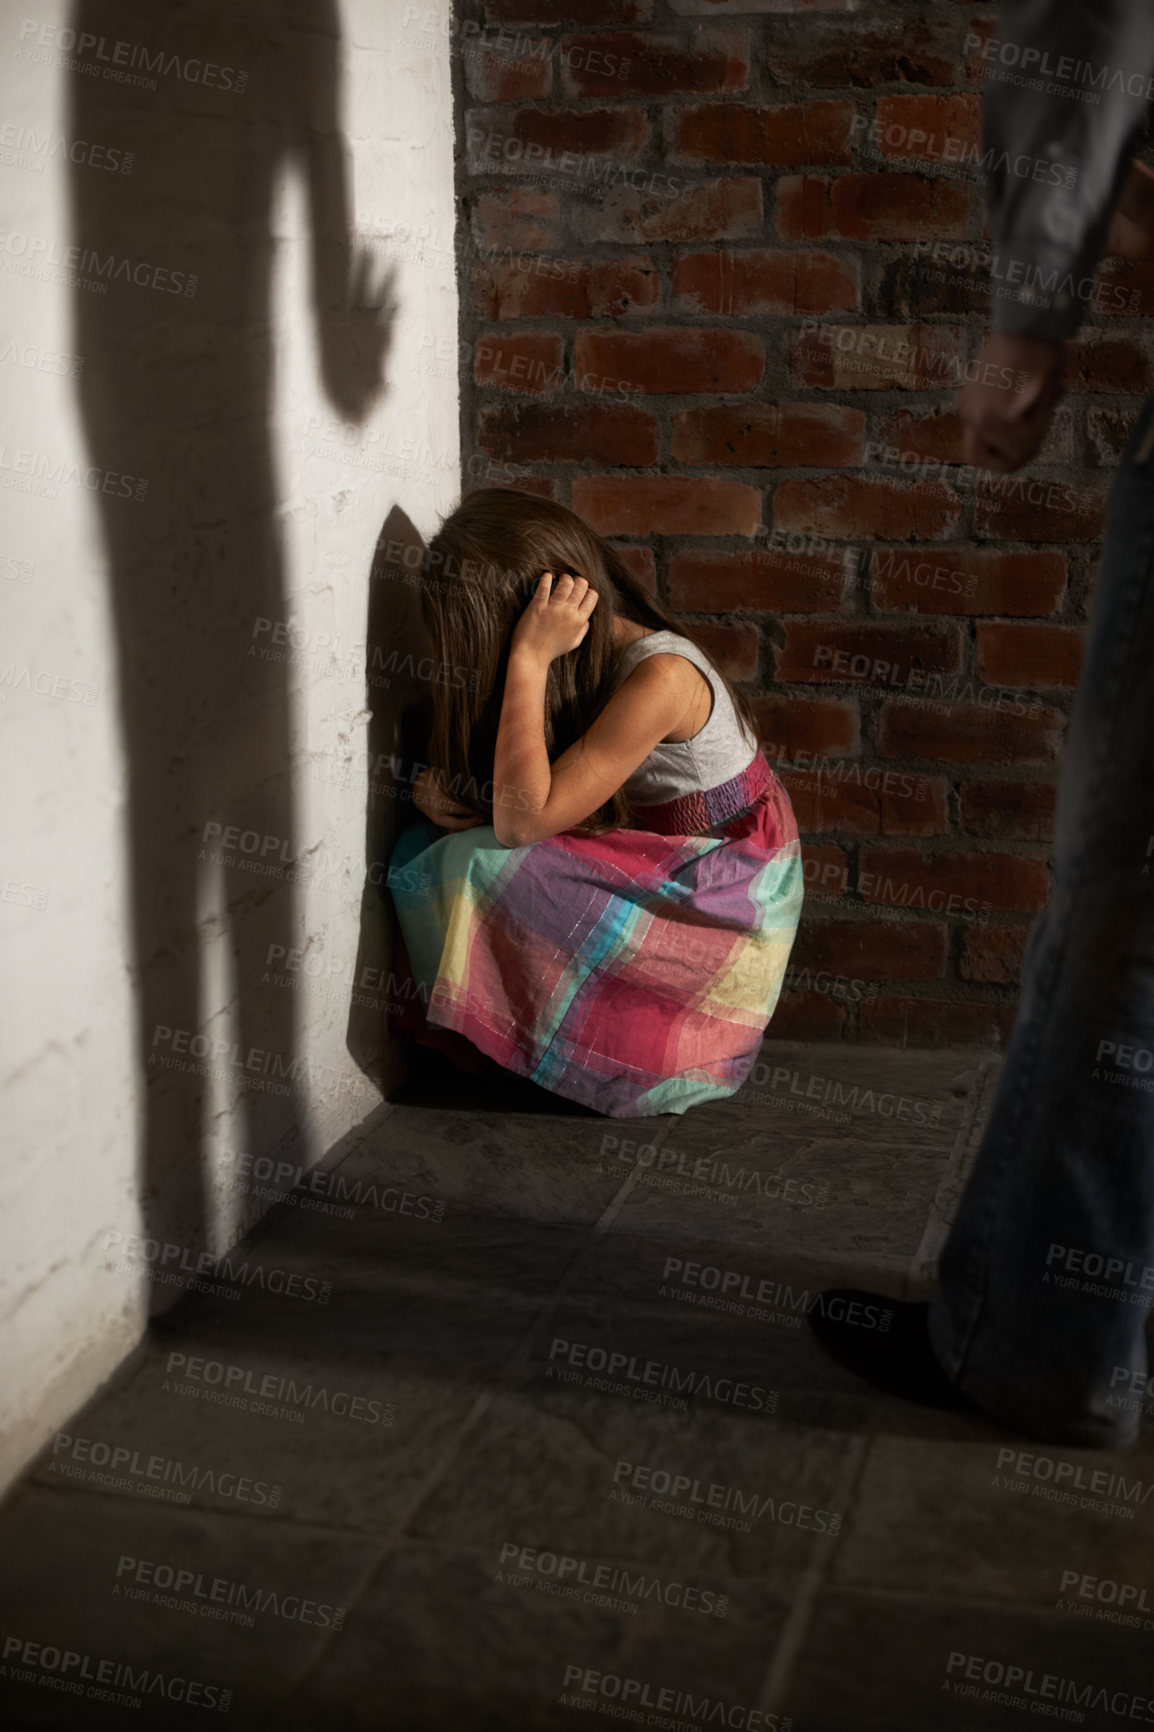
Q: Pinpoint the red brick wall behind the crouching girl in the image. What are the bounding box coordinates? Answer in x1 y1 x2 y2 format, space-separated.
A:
454 0 1154 1044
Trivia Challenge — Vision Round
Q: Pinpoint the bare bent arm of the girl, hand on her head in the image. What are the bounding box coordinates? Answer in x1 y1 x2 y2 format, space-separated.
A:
492 572 700 847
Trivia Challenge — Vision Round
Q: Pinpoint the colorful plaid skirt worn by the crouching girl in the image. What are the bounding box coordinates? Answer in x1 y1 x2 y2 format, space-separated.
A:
388 752 802 1119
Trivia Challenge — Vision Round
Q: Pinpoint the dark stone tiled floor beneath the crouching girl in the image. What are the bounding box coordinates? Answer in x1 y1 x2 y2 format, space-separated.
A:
0 1043 1154 1732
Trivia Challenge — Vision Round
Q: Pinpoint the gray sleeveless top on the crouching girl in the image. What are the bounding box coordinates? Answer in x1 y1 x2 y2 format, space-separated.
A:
617 632 761 805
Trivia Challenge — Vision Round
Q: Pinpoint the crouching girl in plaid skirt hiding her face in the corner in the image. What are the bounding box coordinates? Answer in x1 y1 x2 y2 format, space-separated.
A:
388 488 802 1119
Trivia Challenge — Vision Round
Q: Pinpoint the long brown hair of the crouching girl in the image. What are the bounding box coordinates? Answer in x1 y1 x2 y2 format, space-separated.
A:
421 487 757 833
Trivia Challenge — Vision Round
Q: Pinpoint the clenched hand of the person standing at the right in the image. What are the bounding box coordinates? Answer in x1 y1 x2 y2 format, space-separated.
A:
958 331 1064 475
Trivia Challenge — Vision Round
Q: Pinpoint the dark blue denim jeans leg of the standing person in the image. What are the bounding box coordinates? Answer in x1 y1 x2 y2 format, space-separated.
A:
929 397 1154 1446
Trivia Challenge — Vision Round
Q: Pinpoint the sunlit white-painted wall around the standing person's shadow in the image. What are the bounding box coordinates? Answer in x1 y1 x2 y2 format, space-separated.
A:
0 0 459 1483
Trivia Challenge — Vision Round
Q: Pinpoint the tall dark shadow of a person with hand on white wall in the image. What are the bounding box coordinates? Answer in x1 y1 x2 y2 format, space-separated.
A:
64 0 392 1308
